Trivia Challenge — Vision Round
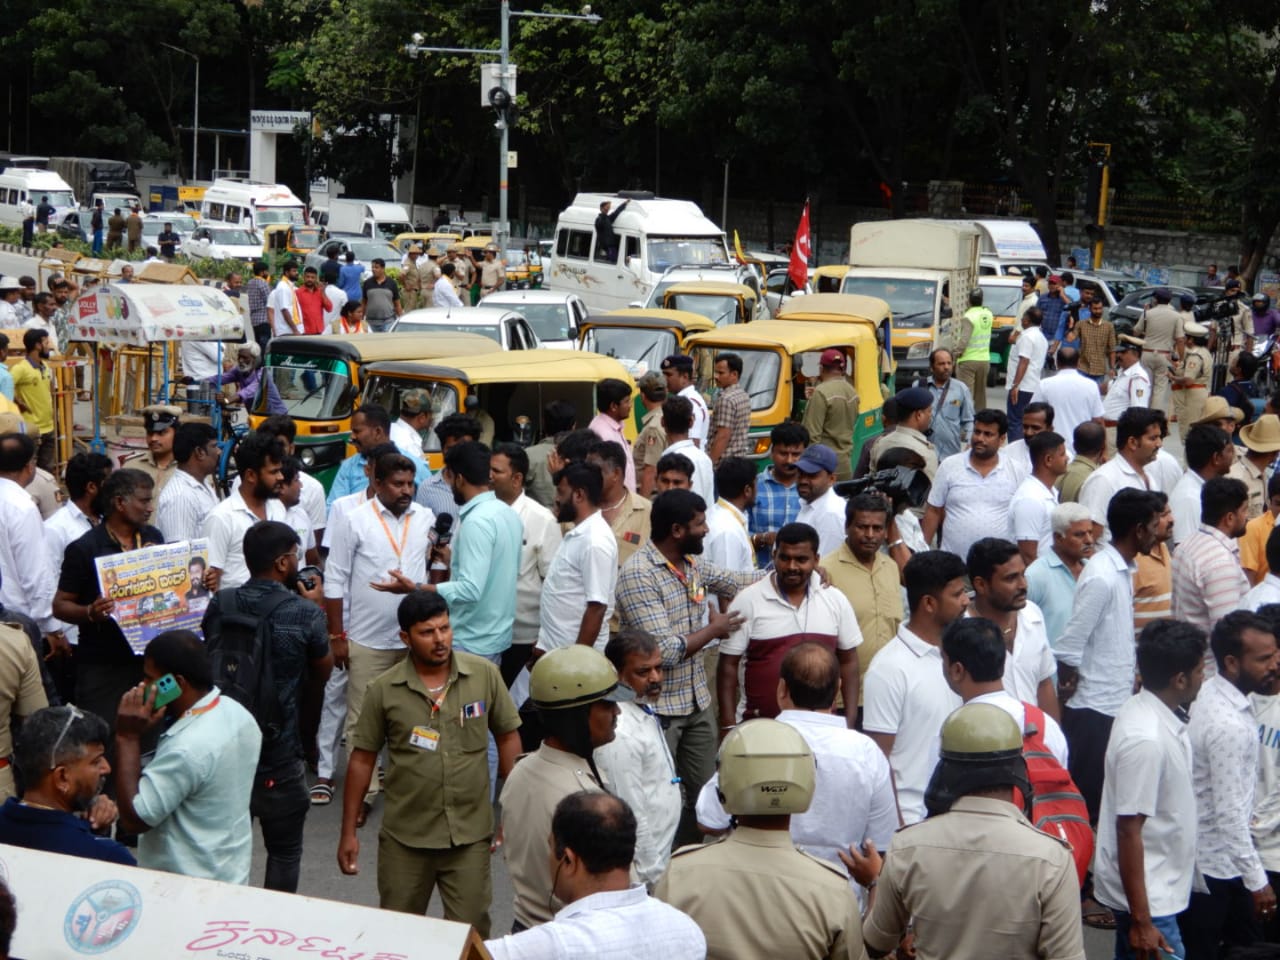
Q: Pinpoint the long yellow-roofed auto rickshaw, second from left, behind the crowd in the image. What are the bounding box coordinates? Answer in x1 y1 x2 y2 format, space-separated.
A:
361 349 636 470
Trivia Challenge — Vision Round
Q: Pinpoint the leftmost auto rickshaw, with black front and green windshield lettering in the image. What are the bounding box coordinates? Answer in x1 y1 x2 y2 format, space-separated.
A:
250 333 502 489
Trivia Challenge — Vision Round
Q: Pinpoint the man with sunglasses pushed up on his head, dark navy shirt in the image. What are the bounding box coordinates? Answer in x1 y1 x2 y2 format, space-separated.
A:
0 707 137 867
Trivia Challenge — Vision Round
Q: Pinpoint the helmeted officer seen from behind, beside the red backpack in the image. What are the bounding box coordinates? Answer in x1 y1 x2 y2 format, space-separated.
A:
842 703 1084 960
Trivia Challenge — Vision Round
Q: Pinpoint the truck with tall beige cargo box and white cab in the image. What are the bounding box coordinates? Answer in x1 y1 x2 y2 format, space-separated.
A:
841 219 982 383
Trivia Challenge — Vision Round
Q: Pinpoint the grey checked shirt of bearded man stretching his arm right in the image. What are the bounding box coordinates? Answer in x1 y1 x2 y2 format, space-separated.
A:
617 543 764 717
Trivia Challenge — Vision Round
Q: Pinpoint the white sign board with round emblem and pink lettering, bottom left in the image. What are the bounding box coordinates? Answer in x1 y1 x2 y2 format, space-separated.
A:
0 845 489 960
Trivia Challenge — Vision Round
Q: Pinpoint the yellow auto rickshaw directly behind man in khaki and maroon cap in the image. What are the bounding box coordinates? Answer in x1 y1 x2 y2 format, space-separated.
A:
685 320 883 470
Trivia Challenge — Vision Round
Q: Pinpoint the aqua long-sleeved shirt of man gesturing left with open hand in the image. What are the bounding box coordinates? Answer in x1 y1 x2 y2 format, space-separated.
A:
435 490 525 657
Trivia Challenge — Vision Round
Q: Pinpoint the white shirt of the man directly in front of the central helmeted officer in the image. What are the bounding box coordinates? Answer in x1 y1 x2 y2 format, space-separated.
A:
698 709 897 896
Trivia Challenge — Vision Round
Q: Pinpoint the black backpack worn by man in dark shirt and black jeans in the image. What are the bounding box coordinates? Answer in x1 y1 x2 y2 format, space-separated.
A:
204 588 293 742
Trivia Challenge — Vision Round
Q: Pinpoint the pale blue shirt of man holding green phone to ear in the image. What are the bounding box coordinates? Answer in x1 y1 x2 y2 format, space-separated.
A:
133 687 262 883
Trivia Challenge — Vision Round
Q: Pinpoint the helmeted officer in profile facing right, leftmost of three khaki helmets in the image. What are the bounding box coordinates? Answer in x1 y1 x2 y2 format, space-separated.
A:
502 644 635 933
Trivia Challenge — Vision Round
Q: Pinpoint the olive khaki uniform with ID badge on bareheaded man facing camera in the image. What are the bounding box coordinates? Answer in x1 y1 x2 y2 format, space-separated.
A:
351 650 519 937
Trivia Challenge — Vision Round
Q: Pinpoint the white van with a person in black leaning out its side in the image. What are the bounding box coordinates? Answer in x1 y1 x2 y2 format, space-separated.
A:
545 192 731 310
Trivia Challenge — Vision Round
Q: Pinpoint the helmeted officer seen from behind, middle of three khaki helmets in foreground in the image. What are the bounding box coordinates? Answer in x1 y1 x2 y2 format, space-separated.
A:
654 718 865 960
